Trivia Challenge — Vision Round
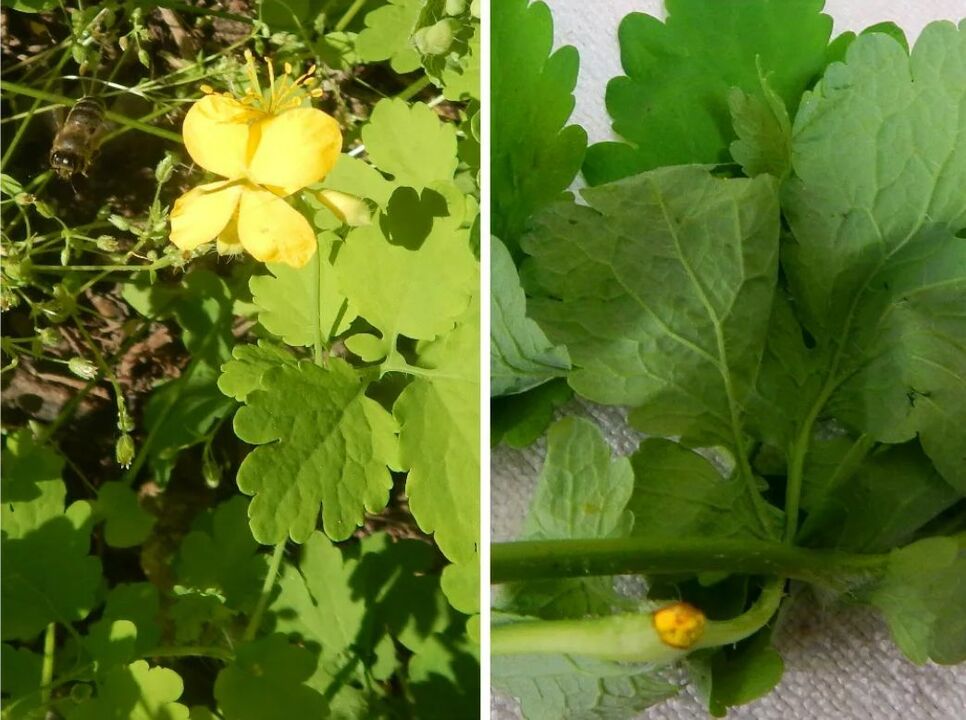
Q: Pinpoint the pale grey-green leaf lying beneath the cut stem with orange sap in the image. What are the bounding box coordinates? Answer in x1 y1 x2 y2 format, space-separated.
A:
491 655 677 720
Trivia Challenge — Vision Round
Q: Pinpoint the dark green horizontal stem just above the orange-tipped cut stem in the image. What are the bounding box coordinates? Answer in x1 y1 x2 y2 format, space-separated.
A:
490 538 888 586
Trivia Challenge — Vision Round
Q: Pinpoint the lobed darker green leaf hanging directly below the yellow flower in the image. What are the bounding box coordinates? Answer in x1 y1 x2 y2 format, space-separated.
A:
235 358 397 545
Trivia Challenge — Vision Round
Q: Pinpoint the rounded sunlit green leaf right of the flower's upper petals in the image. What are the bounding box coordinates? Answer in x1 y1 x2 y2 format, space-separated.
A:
362 99 457 190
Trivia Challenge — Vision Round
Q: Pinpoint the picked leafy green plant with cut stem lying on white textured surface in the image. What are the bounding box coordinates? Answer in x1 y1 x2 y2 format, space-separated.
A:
491 0 966 718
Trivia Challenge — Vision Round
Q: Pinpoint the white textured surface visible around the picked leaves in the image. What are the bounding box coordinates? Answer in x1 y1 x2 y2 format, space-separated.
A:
491 0 966 720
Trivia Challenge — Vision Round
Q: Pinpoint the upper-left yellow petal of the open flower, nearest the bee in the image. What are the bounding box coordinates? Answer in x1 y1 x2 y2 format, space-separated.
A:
181 95 264 180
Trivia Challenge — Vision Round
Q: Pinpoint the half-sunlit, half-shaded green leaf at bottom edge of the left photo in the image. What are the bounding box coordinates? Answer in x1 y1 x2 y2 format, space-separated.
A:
67 660 188 720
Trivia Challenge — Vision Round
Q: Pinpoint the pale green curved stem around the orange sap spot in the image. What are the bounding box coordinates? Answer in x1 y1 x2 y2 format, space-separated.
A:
490 579 783 664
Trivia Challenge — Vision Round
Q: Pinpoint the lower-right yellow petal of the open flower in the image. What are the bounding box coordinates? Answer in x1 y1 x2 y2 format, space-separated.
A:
238 186 317 267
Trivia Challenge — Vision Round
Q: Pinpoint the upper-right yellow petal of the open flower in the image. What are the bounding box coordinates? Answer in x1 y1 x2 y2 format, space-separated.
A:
248 108 342 195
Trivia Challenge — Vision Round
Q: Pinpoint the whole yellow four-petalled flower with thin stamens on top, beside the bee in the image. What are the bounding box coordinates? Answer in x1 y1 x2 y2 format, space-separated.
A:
171 52 342 267
